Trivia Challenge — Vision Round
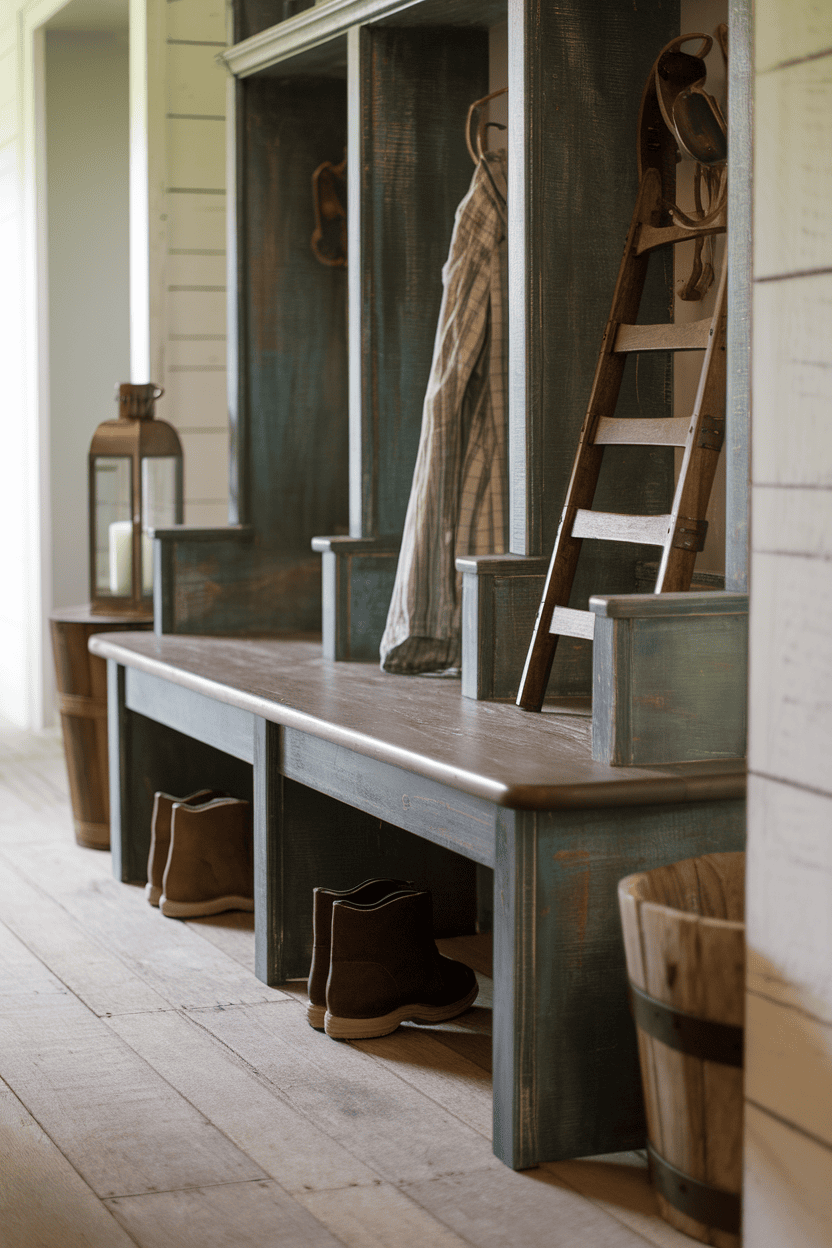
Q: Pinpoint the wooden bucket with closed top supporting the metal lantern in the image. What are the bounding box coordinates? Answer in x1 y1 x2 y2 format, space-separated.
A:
50 607 150 850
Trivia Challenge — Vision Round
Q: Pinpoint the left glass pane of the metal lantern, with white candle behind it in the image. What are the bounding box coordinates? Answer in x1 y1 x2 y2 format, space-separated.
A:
94 456 132 598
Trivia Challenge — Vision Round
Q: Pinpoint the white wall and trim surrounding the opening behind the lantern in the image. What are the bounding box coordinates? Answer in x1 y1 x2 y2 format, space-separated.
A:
0 0 228 726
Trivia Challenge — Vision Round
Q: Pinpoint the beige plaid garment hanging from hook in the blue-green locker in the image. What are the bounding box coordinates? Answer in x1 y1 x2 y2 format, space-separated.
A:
380 151 508 673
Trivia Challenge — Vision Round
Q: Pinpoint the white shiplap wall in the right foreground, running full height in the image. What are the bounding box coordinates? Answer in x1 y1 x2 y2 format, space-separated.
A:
745 0 832 1248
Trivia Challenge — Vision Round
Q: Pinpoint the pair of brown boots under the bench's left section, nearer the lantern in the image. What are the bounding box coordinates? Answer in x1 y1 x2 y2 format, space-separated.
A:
145 789 254 919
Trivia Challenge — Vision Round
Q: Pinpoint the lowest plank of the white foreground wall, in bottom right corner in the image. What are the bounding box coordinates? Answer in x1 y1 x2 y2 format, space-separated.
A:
742 1108 832 1248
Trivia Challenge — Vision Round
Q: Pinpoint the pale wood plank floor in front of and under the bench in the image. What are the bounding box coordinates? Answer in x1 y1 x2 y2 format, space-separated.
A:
0 725 691 1248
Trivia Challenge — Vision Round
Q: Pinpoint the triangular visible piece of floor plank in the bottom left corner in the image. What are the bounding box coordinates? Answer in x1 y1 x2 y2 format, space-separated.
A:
0 1090 135 1248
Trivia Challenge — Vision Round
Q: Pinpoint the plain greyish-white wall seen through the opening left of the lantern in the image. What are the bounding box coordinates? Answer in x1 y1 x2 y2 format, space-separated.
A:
45 26 130 607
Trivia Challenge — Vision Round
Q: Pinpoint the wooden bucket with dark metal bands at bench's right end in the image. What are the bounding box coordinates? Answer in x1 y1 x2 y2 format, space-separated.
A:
619 854 745 1248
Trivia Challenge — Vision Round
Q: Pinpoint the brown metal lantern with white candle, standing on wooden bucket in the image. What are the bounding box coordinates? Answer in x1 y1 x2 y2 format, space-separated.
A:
90 382 182 617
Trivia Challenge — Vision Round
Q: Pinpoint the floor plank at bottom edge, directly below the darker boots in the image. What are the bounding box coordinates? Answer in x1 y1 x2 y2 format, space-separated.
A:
298 1183 468 1248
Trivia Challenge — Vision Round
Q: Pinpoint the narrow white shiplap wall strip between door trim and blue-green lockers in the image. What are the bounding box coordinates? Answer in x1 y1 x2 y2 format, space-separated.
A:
157 0 228 525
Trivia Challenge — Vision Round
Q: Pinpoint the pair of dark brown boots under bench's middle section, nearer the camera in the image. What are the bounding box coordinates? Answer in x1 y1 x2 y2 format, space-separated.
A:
307 880 479 1040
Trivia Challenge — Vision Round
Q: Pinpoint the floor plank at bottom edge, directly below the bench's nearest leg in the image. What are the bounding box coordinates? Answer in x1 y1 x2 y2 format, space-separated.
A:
402 1166 644 1248
